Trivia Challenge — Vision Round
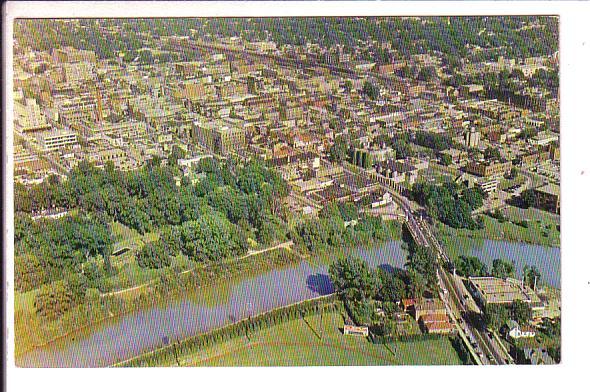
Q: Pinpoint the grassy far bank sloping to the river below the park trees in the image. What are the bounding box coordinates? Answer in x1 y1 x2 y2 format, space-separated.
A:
15 248 299 359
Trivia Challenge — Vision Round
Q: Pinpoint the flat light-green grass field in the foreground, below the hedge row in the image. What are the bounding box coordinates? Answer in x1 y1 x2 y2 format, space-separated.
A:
161 313 461 366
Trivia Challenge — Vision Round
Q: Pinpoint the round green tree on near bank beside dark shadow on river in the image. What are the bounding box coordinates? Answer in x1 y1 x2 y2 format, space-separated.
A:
329 256 377 301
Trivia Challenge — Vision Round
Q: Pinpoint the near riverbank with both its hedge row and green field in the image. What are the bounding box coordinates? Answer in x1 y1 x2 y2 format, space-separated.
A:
118 296 461 367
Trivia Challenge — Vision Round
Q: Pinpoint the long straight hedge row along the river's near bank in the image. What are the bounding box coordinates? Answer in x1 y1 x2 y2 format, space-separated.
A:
113 294 342 367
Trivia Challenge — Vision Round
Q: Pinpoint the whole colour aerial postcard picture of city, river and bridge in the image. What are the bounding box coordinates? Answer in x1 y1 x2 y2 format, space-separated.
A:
8 15 561 371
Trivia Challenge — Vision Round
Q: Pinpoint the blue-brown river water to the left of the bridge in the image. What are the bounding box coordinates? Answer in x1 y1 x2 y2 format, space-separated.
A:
17 241 407 367
